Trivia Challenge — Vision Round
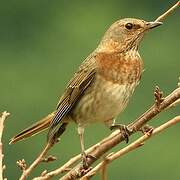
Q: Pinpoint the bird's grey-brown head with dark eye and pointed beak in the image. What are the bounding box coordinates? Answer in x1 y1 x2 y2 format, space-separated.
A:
99 18 162 51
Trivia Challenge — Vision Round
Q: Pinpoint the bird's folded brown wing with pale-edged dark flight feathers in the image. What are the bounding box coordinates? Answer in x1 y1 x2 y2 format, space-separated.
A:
48 56 96 139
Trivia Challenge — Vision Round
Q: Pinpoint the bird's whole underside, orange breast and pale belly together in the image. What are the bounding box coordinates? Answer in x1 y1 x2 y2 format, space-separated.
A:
72 51 142 125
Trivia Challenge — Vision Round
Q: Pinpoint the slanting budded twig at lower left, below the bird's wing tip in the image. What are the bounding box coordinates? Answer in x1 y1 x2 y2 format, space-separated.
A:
18 142 53 180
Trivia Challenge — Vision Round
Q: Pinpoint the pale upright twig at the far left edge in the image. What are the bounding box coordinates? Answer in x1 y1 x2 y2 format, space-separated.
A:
0 111 10 179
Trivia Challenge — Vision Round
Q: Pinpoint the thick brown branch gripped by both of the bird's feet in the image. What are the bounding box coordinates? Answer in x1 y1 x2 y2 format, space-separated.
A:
61 88 180 180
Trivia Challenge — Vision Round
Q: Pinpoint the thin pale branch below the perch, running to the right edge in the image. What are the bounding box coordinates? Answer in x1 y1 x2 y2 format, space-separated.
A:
81 116 180 180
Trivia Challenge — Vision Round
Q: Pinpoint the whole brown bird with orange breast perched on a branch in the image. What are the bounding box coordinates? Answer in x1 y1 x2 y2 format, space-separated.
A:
10 18 162 166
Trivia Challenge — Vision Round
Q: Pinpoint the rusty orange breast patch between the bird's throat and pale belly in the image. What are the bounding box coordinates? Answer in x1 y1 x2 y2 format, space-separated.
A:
96 51 143 84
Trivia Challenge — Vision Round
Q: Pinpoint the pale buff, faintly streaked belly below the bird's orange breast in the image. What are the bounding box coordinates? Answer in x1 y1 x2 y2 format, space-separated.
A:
72 76 137 125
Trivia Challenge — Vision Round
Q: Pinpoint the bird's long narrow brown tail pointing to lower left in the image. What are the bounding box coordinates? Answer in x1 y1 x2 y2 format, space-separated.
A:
9 111 56 144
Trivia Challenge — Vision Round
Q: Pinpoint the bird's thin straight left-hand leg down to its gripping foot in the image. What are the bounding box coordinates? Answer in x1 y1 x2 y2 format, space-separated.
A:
78 126 88 169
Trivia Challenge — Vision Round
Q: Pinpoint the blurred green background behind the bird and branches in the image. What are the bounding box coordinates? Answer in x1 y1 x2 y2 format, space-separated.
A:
0 0 180 180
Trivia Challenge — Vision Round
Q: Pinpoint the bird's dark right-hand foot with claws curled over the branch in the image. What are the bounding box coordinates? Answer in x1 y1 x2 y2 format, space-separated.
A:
110 124 131 143
